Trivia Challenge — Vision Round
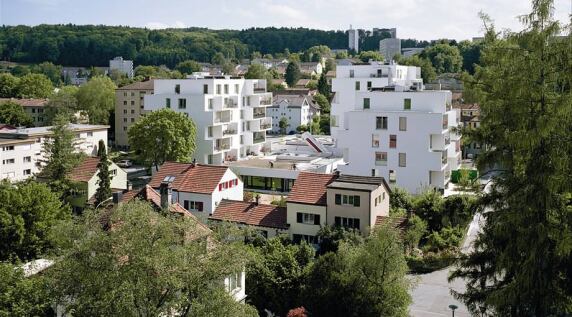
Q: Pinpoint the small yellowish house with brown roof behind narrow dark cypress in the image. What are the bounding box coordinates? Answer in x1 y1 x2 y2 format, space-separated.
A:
67 157 127 211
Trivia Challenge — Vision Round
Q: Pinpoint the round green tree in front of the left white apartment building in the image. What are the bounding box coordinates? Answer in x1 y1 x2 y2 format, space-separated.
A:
128 109 196 170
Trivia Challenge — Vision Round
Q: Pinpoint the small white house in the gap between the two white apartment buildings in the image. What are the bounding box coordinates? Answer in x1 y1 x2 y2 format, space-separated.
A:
266 94 320 134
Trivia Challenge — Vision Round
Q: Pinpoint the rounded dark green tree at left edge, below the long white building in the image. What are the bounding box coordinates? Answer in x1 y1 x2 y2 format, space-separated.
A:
0 181 70 261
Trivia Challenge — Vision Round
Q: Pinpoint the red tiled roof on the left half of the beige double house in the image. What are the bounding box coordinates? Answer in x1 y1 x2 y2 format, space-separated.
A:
288 172 337 206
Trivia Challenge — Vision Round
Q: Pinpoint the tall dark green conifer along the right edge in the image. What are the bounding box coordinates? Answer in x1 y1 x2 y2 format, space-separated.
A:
453 0 572 317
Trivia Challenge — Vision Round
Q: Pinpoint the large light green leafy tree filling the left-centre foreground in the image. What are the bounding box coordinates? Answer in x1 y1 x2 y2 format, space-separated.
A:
46 201 256 317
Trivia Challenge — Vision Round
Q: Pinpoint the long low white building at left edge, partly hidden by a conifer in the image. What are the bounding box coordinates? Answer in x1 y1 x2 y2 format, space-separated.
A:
0 124 109 181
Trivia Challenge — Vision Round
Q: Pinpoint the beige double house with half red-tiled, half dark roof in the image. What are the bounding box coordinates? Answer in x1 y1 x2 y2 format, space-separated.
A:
286 172 390 244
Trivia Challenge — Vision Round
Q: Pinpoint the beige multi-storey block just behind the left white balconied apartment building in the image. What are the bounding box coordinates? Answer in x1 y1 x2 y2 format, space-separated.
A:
115 79 153 149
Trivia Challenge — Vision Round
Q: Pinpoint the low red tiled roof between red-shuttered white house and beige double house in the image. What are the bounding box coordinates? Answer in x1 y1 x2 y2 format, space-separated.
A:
209 199 288 229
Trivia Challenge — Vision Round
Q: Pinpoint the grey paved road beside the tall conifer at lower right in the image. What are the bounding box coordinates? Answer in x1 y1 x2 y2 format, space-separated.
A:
409 184 490 317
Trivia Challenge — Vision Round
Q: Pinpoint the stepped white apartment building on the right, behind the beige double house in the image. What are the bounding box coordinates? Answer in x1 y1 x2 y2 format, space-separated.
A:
332 63 461 193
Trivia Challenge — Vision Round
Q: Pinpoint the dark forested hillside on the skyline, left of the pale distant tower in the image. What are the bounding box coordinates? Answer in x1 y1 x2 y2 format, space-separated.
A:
0 25 347 67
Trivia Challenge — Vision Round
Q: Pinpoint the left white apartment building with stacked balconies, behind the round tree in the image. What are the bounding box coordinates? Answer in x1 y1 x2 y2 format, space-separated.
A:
144 74 272 165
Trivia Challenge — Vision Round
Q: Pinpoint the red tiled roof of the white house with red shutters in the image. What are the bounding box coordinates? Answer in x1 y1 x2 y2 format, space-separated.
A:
149 162 228 194
